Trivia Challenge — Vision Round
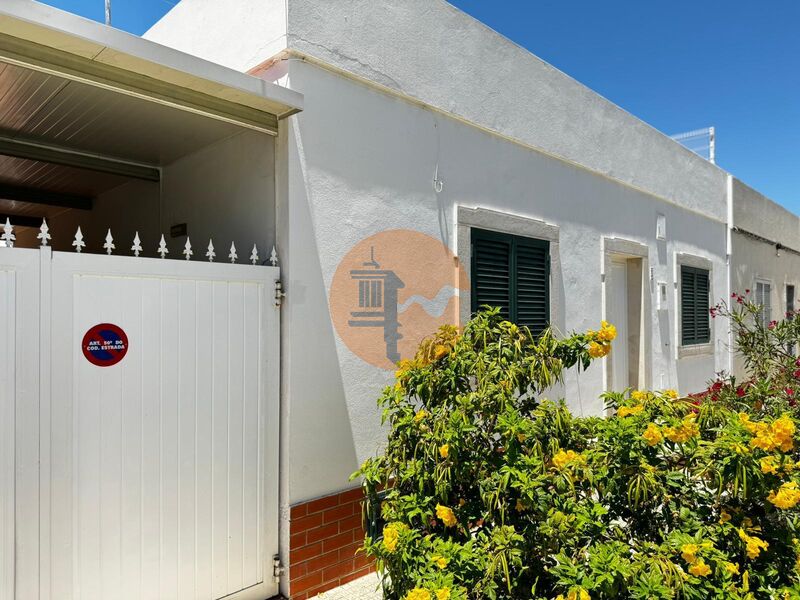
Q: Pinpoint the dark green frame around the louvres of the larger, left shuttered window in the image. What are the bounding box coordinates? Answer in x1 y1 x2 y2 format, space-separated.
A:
469 226 552 334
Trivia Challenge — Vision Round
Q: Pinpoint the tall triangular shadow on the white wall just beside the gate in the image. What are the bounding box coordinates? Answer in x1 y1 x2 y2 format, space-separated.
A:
284 123 360 503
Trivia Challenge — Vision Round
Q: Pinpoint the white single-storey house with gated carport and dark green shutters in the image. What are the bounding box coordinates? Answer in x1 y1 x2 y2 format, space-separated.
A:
0 0 800 600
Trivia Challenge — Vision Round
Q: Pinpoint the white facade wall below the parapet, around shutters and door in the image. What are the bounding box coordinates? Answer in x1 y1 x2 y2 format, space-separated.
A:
278 61 726 503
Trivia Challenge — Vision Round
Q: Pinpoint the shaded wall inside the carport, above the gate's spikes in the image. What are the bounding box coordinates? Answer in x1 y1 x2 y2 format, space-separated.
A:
19 131 275 262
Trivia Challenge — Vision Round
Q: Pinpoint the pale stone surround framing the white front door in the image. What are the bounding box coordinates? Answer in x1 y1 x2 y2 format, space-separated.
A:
601 237 654 398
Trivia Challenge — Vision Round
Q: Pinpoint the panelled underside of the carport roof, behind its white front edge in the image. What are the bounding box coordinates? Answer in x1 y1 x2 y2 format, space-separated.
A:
0 62 256 226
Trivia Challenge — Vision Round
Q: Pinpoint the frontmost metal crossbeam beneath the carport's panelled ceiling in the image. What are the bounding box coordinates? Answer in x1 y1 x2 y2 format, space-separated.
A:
0 135 161 181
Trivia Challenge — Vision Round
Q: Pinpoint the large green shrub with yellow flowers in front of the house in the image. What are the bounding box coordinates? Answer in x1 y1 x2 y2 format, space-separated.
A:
356 311 800 600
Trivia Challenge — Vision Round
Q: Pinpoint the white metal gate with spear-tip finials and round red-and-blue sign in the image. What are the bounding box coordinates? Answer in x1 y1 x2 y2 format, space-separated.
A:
0 221 279 600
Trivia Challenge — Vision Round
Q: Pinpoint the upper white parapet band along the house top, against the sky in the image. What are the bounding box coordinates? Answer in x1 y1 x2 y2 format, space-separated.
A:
145 0 726 225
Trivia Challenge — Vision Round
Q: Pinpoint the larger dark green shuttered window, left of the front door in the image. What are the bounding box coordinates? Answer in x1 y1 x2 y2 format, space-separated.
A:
471 229 550 335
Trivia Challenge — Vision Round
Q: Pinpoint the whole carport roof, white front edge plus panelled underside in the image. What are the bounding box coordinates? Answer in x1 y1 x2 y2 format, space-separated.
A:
0 0 303 226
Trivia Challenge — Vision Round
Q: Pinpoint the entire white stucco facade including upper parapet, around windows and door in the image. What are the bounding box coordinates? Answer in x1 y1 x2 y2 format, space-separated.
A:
147 0 740 508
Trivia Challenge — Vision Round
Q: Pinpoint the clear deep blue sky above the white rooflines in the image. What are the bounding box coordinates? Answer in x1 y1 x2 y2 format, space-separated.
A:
39 0 800 213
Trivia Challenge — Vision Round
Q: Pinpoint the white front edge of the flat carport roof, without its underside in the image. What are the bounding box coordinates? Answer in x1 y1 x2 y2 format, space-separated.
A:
0 0 303 134
